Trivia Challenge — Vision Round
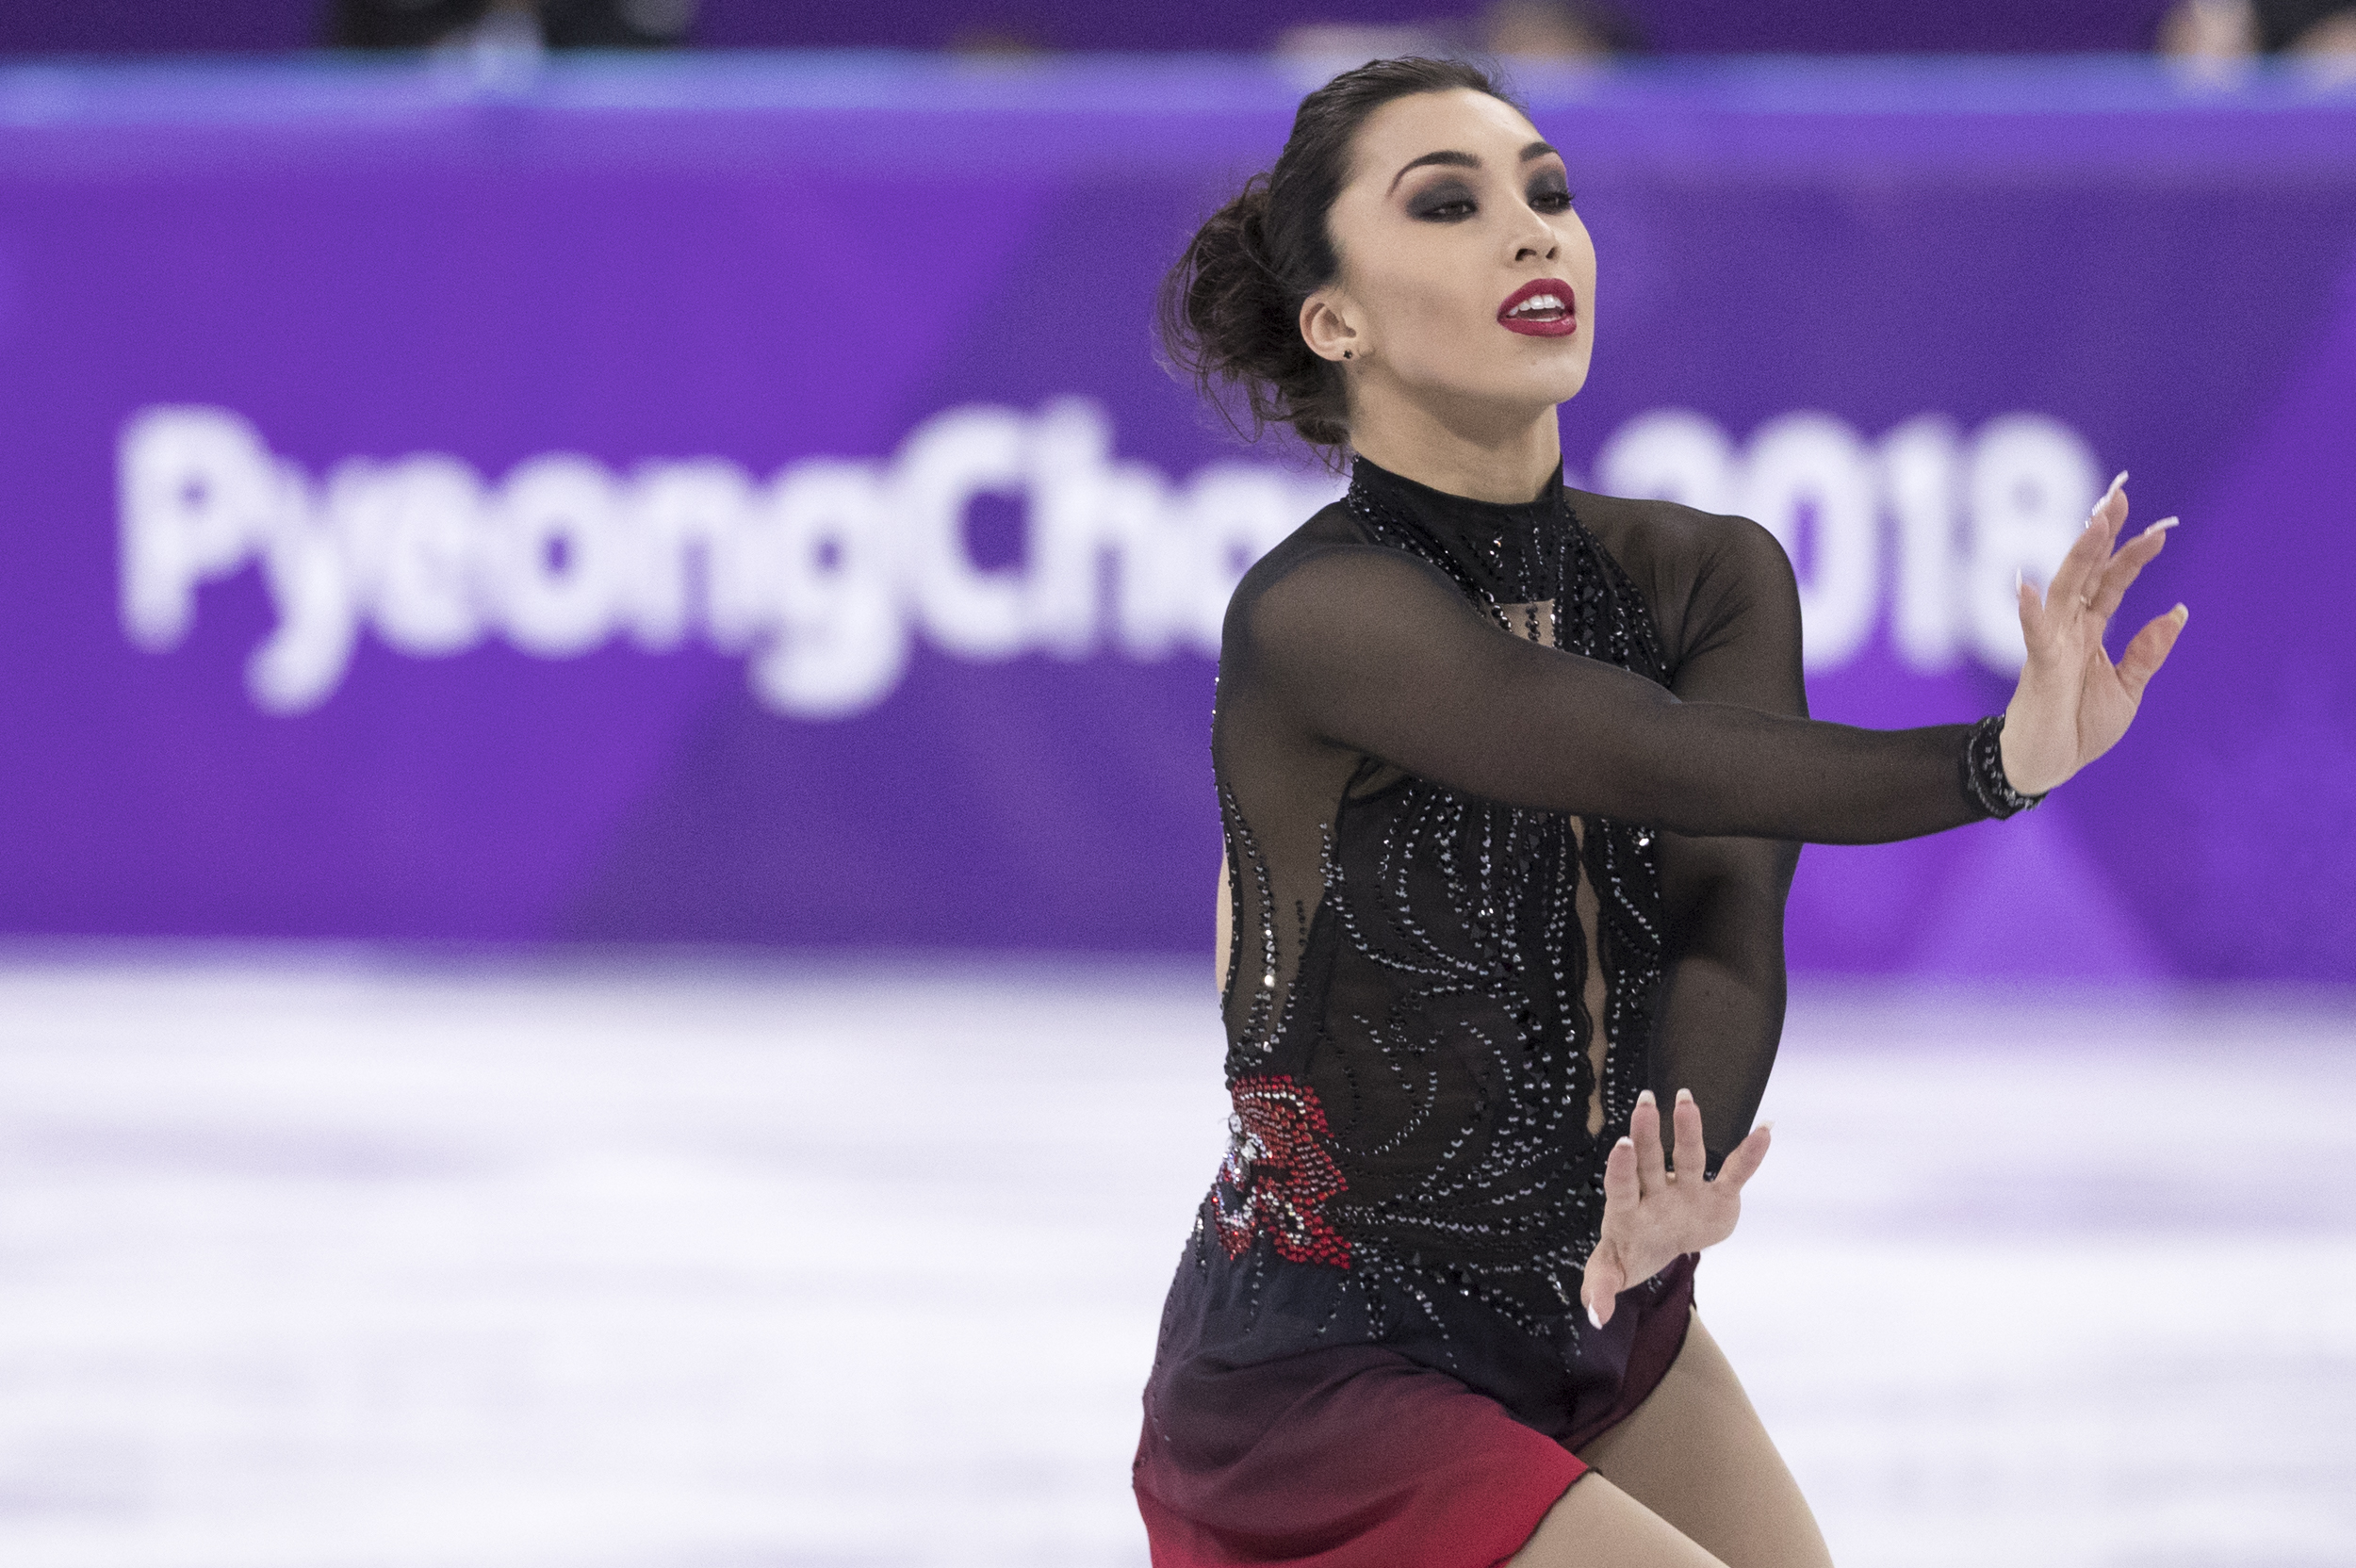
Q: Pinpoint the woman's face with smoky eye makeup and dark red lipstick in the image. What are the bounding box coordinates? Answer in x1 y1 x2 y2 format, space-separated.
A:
1301 91 1595 426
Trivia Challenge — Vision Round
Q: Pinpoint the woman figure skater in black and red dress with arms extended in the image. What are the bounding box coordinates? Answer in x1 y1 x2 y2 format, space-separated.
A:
1136 58 2184 1568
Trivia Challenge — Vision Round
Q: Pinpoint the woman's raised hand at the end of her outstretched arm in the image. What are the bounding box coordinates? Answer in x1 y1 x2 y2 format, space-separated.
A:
2001 473 2189 795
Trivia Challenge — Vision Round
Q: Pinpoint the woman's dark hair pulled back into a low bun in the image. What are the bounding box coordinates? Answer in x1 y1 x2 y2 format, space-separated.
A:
1157 57 1520 448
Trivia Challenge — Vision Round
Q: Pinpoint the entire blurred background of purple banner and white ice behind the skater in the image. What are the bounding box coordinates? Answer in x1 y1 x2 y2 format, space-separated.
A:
0 0 2356 1568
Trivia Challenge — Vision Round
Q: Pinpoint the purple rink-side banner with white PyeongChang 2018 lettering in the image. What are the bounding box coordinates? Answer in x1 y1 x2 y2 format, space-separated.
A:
0 57 2356 979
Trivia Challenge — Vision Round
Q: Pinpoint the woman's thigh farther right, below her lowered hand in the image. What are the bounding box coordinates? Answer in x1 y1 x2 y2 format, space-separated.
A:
1562 1316 1833 1568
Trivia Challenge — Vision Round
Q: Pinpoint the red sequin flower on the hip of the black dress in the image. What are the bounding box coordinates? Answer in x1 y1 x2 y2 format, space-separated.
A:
1216 1076 1350 1269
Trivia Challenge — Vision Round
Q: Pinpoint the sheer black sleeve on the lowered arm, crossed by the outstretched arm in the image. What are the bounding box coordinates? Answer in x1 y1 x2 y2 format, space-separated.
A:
1652 518 1808 1172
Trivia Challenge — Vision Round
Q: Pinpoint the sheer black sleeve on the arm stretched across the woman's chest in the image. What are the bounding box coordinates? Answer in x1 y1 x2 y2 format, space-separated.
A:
1230 544 1982 847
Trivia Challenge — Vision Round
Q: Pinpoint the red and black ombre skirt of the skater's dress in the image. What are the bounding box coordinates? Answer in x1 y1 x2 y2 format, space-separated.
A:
1136 1269 1692 1568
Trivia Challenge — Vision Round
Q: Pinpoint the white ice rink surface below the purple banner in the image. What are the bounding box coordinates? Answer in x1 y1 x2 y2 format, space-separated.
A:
0 949 2356 1568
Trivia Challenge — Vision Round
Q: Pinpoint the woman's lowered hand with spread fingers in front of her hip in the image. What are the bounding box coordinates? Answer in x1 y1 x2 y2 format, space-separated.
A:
1579 1090 1772 1328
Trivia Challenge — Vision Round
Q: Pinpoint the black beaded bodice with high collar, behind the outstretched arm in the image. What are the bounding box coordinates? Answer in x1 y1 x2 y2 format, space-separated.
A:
1211 462 1666 1328
